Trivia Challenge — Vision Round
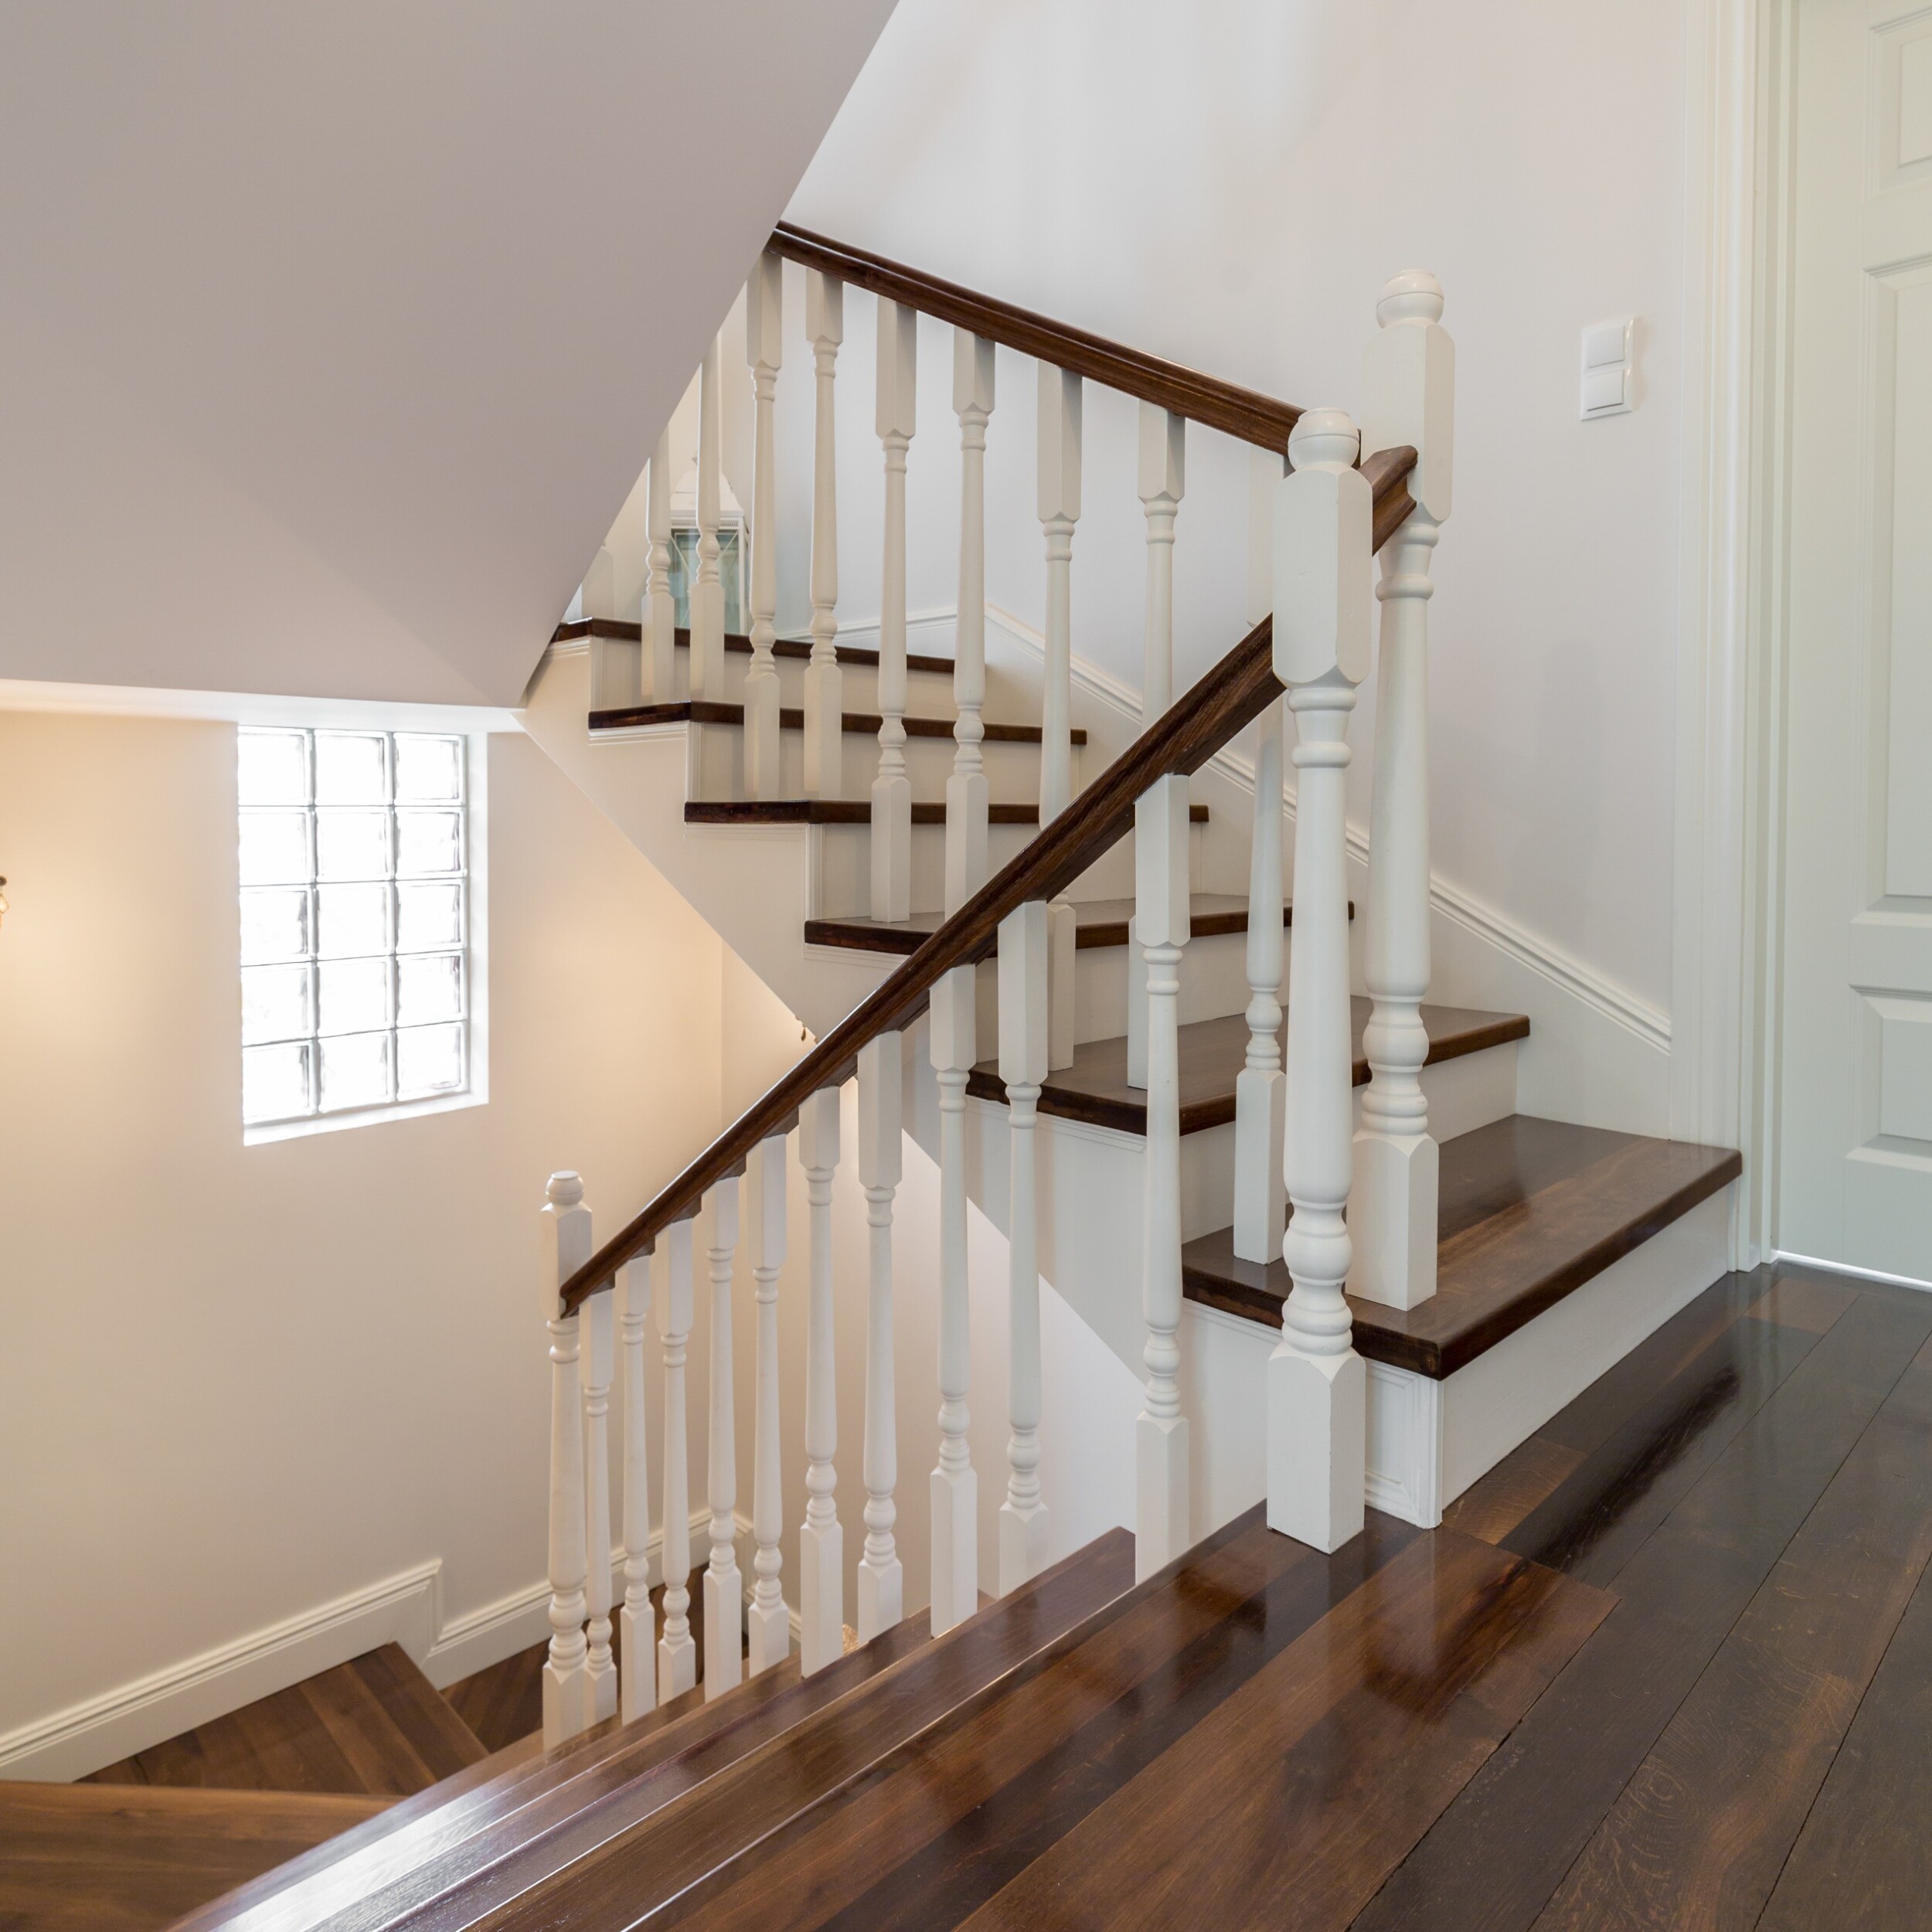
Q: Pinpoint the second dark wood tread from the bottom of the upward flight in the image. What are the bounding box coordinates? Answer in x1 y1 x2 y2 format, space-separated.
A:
966 999 1530 1134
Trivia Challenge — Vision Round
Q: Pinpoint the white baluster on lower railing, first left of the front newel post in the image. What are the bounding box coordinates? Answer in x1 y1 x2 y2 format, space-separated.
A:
1134 773 1190 1579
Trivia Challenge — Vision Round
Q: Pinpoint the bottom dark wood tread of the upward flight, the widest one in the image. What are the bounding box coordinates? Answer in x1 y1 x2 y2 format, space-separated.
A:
1181 1121 1745 1379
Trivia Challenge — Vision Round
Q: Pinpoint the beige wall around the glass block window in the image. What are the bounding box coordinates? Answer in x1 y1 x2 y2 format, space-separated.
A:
0 713 734 1776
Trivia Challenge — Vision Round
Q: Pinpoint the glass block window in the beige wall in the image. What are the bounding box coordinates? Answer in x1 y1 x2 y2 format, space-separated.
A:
238 729 470 1127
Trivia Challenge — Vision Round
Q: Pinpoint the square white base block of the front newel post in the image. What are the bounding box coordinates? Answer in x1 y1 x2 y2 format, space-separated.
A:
1267 1341 1368 1553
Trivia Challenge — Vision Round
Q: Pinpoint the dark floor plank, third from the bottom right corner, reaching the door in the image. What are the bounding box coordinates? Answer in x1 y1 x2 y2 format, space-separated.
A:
1359 1294 1932 1932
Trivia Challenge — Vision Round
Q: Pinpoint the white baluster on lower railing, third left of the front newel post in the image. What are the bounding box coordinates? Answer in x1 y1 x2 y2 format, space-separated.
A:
927 966 980 1637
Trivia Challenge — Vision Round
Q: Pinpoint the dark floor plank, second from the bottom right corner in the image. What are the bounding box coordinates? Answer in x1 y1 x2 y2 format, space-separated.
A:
1536 1349 1932 1932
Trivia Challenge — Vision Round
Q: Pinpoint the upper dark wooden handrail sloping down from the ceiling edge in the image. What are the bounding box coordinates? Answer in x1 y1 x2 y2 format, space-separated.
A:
771 223 1302 456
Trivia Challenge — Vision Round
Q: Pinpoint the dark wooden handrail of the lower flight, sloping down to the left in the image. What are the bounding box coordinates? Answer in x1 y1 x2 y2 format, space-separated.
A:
560 447 1417 1312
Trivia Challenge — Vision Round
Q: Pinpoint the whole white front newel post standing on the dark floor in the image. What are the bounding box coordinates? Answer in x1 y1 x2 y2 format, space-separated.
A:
1267 410 1374 1549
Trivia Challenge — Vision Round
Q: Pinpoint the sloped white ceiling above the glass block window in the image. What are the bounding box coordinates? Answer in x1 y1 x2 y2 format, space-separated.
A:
0 0 893 706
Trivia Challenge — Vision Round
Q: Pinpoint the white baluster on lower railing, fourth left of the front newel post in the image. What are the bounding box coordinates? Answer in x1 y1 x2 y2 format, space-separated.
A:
858 1034 906 1645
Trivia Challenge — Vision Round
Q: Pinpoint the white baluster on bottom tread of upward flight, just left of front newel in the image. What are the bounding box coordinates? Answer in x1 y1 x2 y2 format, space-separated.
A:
1235 451 1287 1262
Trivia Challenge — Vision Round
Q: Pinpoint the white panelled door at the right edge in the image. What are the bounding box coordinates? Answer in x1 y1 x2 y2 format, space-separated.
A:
1776 0 1932 1281
